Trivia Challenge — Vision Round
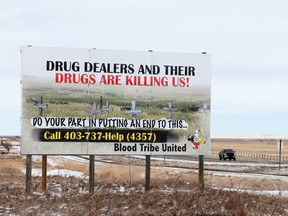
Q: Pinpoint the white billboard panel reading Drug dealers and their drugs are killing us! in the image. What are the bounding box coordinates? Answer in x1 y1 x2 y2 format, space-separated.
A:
21 46 211 155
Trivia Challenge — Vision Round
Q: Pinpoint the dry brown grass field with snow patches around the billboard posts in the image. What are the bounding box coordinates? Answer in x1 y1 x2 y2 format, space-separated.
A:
0 138 288 216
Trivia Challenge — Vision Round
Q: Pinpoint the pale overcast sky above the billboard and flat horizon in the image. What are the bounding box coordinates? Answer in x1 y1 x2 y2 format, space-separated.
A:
0 0 288 136
